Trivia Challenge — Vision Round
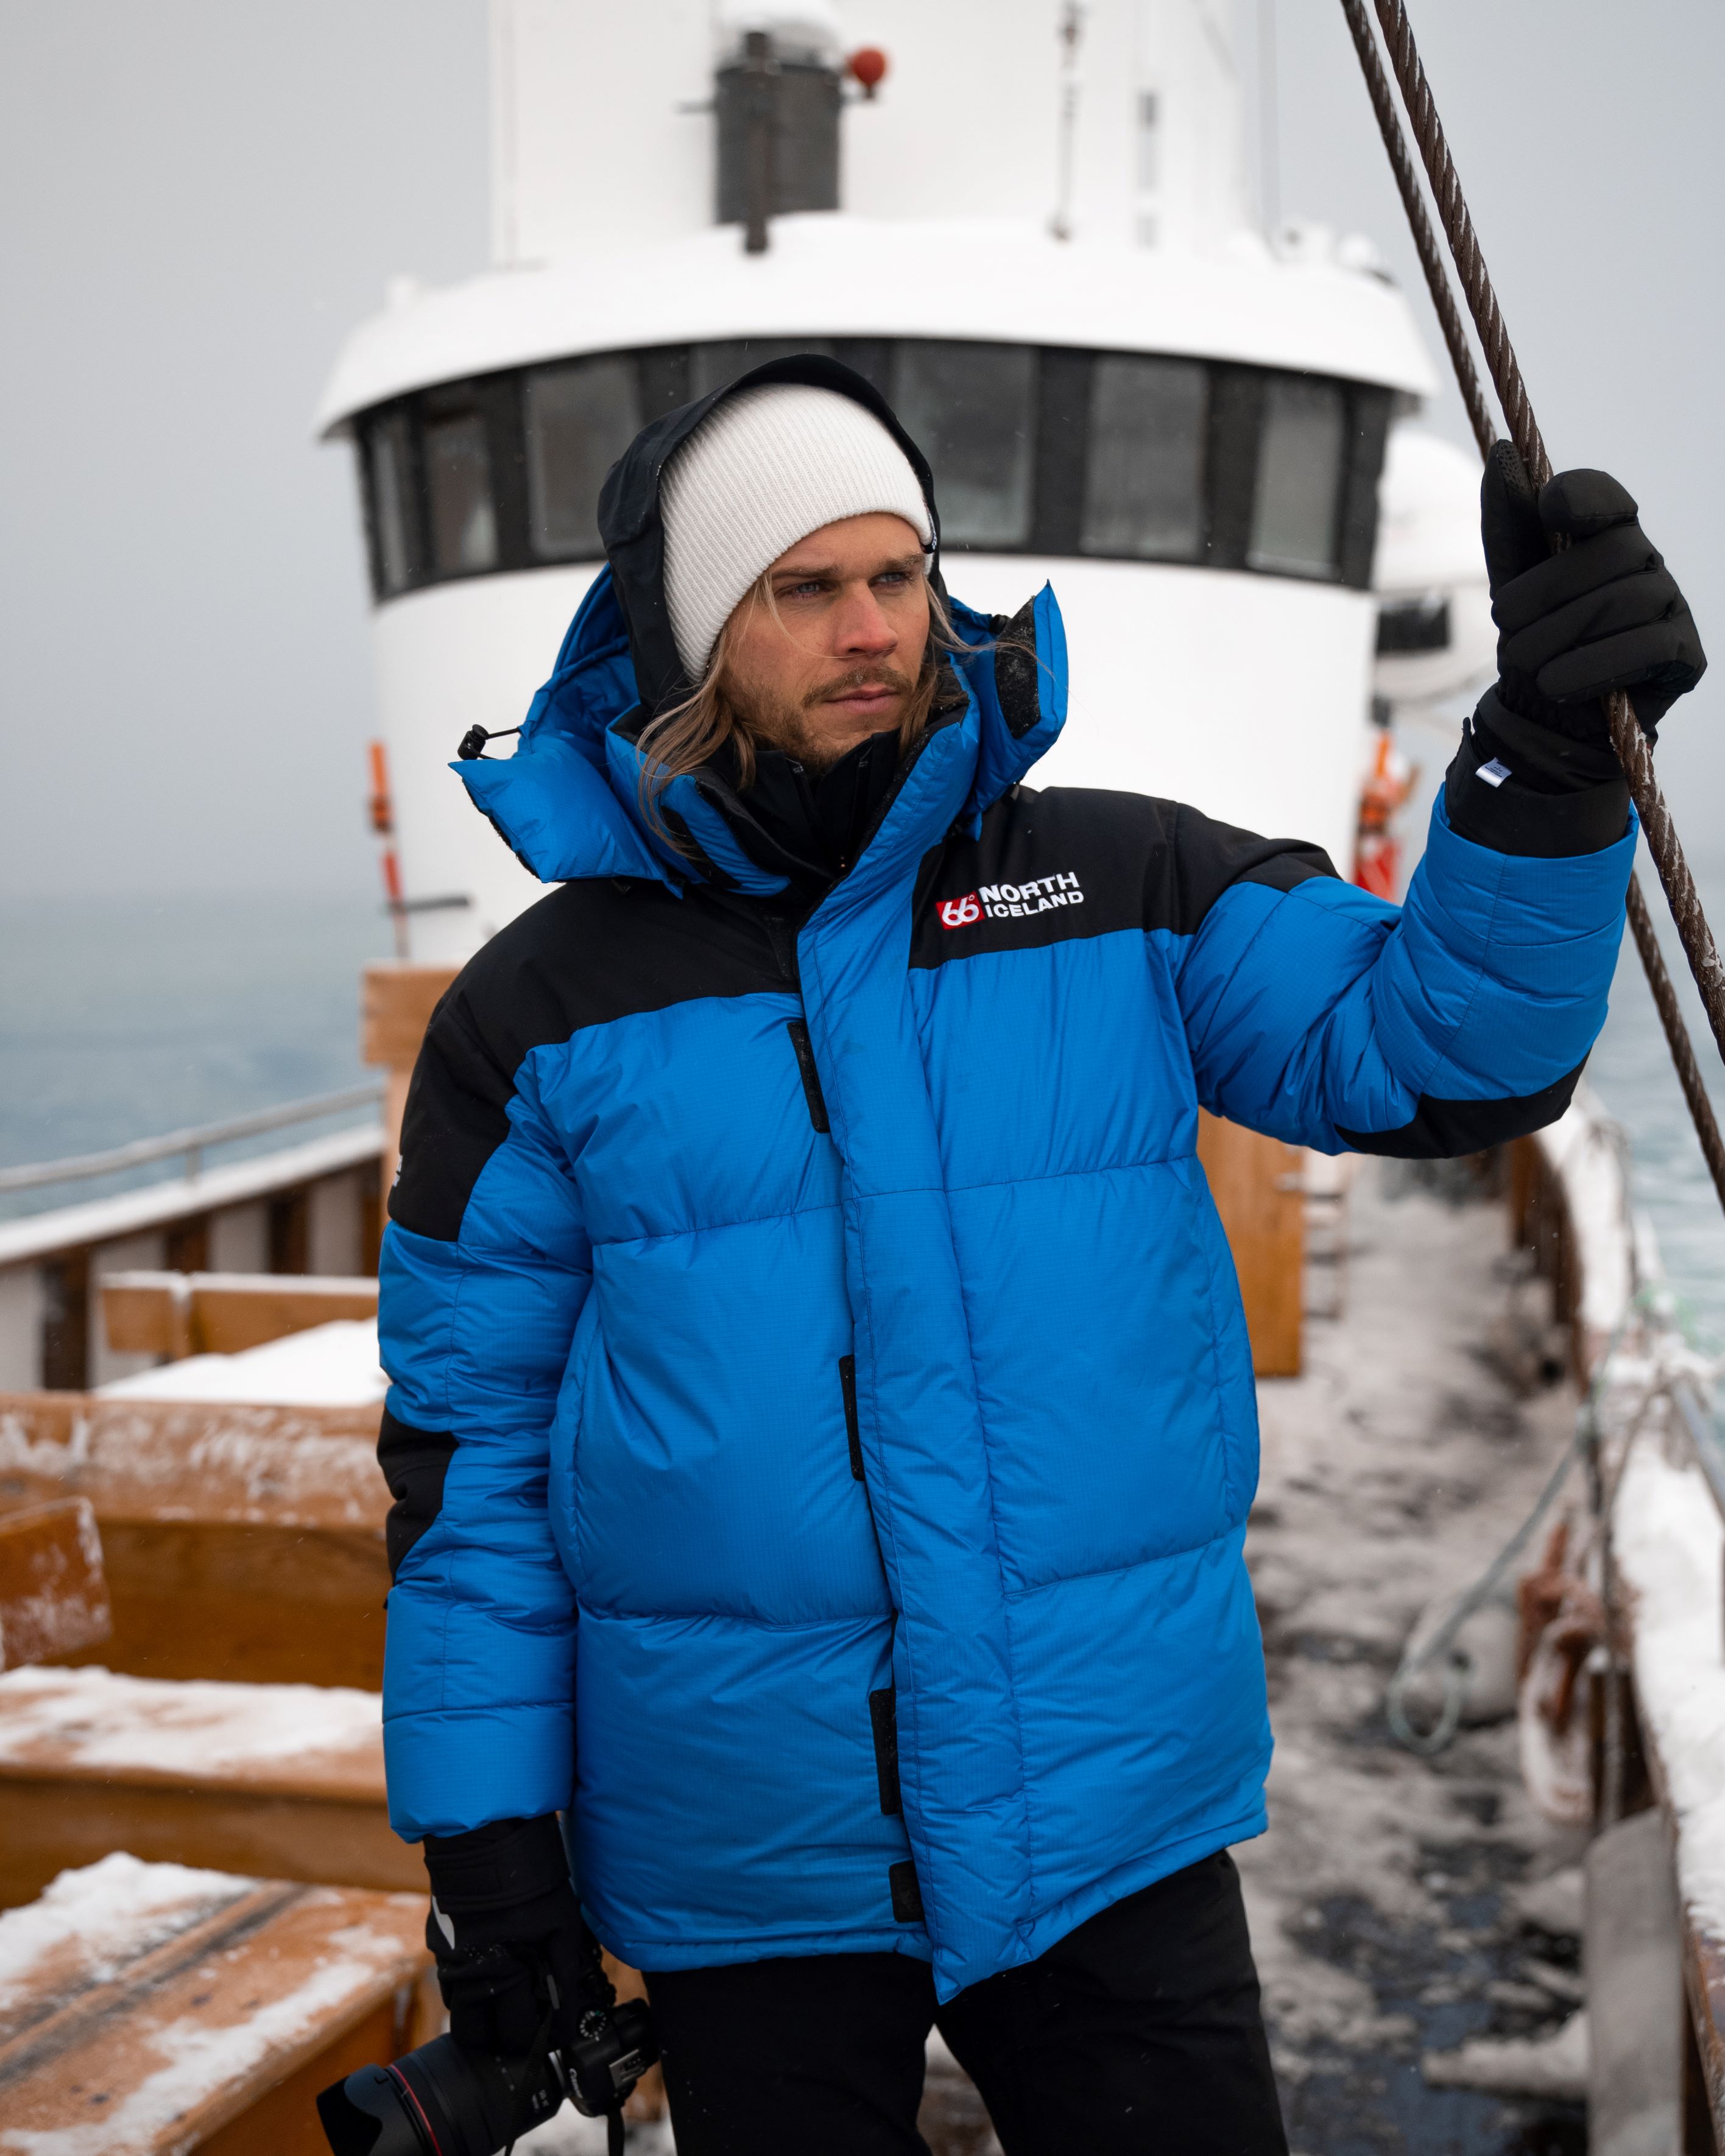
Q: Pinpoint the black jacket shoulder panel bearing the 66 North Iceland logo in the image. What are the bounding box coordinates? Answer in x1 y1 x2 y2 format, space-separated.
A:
910 787 1335 966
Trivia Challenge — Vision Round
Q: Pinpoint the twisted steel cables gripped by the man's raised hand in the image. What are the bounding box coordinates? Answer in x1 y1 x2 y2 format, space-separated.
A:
1341 0 1725 1205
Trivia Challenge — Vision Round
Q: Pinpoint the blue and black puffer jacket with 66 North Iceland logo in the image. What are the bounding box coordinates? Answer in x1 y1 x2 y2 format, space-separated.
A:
382 358 1632 1996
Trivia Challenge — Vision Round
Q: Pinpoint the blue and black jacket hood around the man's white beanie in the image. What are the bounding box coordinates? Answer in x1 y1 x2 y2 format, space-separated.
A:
451 354 1065 893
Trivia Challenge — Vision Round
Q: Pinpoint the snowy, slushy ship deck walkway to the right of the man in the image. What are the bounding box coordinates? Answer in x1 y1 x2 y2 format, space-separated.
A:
1238 1162 1587 2156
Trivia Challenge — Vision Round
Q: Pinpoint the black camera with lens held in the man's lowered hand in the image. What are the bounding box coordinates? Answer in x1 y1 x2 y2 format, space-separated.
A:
317 1999 658 2156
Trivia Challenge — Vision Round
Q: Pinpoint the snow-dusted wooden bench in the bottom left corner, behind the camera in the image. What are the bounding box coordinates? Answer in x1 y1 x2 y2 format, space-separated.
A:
0 1854 438 2156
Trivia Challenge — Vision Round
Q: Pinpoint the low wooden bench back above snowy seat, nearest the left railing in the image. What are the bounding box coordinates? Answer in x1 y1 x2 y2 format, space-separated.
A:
101 1272 378 1362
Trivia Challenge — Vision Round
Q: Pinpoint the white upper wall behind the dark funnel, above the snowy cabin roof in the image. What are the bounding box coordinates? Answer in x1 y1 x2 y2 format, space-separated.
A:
492 0 1249 276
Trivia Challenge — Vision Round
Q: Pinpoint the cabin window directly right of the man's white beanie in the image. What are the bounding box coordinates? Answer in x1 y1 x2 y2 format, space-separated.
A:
893 339 1037 548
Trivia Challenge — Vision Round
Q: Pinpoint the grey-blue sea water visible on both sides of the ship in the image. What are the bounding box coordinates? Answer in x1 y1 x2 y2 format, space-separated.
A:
0 854 1725 1343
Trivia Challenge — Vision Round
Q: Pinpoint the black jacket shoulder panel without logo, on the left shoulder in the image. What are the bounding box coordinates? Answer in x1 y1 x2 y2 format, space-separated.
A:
390 879 785 1242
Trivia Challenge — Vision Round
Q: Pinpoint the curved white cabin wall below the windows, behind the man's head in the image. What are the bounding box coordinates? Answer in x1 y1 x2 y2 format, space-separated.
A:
375 554 1376 964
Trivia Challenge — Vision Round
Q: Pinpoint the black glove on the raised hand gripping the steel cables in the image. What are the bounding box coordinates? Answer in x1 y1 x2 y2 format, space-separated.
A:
1479 442 1708 746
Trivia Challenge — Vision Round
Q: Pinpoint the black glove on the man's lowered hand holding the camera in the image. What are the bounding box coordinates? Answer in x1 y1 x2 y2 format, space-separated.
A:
425 1816 615 2059
